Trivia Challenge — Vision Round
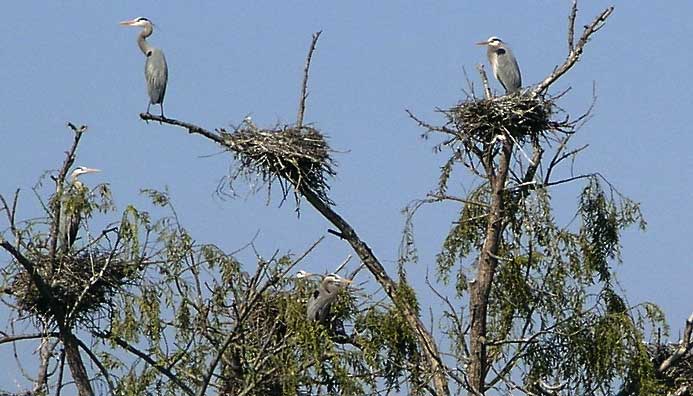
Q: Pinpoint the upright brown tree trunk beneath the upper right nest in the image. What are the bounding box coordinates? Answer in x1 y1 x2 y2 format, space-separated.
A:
467 141 513 395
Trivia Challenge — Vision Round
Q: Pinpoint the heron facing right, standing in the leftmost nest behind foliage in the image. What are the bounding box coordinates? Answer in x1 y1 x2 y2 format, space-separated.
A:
60 166 100 250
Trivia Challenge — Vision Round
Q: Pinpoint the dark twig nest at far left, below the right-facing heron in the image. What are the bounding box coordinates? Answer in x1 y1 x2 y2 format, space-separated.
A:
11 252 138 323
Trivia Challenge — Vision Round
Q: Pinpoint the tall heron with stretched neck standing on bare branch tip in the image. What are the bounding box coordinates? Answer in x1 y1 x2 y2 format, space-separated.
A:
120 17 168 117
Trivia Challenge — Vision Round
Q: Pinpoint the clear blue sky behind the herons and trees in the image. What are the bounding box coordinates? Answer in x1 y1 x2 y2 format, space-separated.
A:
0 1 693 390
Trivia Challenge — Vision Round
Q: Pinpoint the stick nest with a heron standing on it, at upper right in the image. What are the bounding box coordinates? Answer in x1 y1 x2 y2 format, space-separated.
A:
445 95 557 143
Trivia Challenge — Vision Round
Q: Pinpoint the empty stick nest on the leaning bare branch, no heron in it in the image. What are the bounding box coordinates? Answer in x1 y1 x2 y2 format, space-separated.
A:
221 121 336 203
